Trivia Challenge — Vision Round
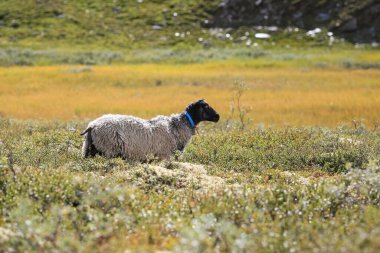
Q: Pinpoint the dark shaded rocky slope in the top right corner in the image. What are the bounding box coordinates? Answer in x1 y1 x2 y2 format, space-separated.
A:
210 0 380 42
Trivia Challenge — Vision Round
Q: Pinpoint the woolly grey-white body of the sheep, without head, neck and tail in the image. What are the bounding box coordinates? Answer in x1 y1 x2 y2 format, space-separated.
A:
89 114 175 160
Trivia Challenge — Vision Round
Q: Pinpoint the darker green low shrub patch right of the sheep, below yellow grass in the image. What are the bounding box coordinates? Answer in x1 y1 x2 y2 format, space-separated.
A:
185 128 379 172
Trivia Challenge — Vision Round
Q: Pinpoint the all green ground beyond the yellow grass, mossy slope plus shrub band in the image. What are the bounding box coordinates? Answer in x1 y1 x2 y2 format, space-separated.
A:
0 0 379 66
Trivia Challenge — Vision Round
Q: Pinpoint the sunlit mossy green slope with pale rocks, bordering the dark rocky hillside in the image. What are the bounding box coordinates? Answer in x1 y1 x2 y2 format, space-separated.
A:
0 0 378 53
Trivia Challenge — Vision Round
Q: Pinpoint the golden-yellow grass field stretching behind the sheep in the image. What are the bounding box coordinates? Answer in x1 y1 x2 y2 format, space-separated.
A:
0 61 380 127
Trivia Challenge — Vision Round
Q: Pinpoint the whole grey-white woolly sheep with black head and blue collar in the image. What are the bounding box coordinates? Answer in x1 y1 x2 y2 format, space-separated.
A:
81 99 219 161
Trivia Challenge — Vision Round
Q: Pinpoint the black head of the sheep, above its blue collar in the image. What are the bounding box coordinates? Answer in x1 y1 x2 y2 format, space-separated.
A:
186 99 220 125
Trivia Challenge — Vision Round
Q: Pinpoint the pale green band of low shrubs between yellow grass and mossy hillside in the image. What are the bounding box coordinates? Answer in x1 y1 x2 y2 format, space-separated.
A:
0 47 380 66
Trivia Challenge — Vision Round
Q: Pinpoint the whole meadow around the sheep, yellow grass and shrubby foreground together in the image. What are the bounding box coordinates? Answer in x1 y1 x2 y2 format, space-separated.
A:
0 50 380 252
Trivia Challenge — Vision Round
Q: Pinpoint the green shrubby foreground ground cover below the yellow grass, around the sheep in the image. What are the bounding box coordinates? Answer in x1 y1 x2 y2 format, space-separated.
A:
0 118 380 252
